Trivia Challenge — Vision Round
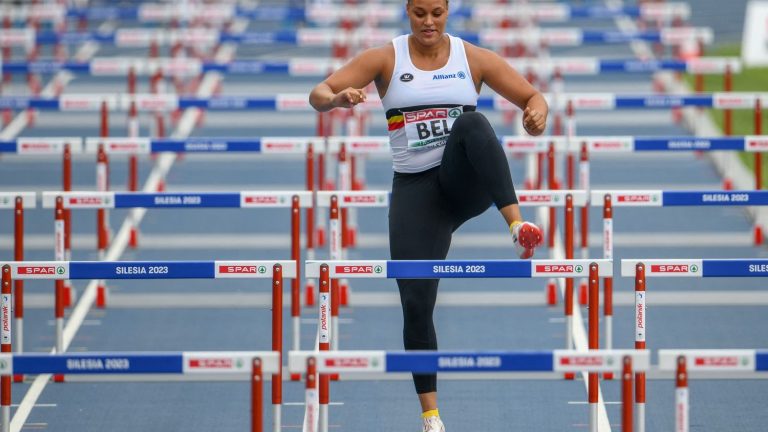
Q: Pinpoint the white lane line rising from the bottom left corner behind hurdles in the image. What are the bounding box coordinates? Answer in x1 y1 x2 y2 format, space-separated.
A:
11 20 247 432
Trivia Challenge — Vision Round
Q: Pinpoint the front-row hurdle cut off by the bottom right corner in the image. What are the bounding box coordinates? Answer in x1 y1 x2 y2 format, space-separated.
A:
659 349 768 432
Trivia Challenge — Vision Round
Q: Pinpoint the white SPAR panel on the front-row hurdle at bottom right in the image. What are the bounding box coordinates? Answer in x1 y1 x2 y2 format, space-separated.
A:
659 349 756 372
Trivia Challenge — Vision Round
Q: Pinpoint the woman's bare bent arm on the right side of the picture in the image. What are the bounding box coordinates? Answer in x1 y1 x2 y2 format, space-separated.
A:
464 42 549 135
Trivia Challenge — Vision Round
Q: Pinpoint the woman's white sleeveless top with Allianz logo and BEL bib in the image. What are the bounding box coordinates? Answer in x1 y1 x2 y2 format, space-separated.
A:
382 35 478 173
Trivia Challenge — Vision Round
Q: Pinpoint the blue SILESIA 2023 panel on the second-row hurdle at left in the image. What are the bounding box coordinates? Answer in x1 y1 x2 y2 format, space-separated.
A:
69 261 215 279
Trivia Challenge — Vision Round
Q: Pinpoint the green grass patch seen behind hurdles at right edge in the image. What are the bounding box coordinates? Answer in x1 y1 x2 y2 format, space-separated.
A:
685 45 768 189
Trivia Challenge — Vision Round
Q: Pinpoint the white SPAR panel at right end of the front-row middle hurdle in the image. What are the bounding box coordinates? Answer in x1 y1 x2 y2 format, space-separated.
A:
553 350 651 372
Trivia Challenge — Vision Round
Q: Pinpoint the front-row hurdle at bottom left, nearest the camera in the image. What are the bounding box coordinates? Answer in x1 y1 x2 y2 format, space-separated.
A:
0 351 281 432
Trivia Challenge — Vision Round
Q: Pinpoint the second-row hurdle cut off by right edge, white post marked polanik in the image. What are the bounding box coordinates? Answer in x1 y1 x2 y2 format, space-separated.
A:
621 259 768 432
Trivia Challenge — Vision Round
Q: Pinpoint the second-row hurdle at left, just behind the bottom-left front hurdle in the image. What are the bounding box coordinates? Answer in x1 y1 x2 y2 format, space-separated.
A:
0 260 298 432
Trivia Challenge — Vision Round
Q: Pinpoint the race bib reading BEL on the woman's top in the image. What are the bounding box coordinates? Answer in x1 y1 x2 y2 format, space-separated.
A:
403 106 463 151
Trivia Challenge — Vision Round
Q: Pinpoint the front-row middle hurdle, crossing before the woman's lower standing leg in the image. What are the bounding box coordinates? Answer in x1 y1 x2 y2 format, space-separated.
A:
288 350 650 432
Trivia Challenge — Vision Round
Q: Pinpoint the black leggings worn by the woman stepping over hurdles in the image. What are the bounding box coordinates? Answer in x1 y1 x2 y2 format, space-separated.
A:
389 111 517 393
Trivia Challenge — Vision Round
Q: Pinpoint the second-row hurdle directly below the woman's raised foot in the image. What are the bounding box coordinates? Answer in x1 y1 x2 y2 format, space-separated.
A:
305 259 613 431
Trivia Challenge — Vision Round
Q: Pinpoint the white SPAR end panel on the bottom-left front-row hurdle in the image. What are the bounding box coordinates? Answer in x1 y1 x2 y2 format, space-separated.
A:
182 351 279 375
